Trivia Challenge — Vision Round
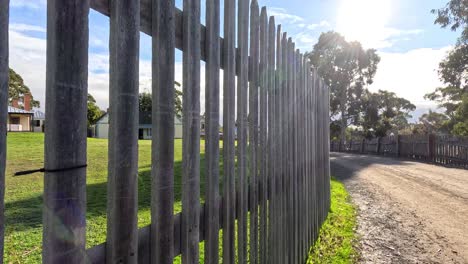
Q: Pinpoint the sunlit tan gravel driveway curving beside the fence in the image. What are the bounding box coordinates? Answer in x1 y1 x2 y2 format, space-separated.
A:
331 153 468 263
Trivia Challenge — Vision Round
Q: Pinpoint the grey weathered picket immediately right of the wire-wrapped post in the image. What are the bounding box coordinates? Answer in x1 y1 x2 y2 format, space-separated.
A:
106 0 140 264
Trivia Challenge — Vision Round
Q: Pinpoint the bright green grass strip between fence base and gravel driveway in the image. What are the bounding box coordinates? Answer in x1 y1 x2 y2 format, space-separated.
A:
307 179 359 264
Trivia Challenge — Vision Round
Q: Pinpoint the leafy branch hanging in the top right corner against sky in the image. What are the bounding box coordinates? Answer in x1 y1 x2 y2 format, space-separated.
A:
431 0 468 43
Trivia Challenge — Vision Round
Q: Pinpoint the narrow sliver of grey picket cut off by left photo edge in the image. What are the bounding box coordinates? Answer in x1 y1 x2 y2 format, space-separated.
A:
0 0 10 264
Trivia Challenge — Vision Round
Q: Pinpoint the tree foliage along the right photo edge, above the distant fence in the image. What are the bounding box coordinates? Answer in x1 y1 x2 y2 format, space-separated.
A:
420 0 468 136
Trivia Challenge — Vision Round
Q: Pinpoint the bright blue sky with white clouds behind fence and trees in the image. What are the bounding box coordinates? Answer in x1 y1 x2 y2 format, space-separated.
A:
9 0 459 119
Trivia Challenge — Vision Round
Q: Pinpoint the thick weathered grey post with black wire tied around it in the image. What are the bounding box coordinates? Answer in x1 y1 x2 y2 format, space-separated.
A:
42 0 89 263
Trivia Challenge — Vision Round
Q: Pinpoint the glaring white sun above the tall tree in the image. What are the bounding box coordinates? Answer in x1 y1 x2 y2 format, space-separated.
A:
337 0 392 48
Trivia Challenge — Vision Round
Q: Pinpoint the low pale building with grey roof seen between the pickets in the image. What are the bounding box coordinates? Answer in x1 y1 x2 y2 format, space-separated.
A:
94 112 182 139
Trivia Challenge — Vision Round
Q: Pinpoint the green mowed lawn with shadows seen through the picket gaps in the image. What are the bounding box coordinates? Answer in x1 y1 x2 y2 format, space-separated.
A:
5 133 222 263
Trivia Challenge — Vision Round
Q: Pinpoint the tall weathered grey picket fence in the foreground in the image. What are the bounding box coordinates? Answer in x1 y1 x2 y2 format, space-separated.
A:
0 0 330 263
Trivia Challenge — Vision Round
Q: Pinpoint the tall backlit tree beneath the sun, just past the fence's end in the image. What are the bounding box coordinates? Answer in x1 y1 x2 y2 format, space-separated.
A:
307 31 380 140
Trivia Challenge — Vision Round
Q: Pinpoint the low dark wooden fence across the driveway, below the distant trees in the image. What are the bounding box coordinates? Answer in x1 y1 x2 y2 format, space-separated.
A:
330 135 468 168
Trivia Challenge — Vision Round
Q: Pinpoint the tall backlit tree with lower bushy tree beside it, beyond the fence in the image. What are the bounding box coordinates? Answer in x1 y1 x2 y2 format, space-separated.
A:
307 31 416 139
